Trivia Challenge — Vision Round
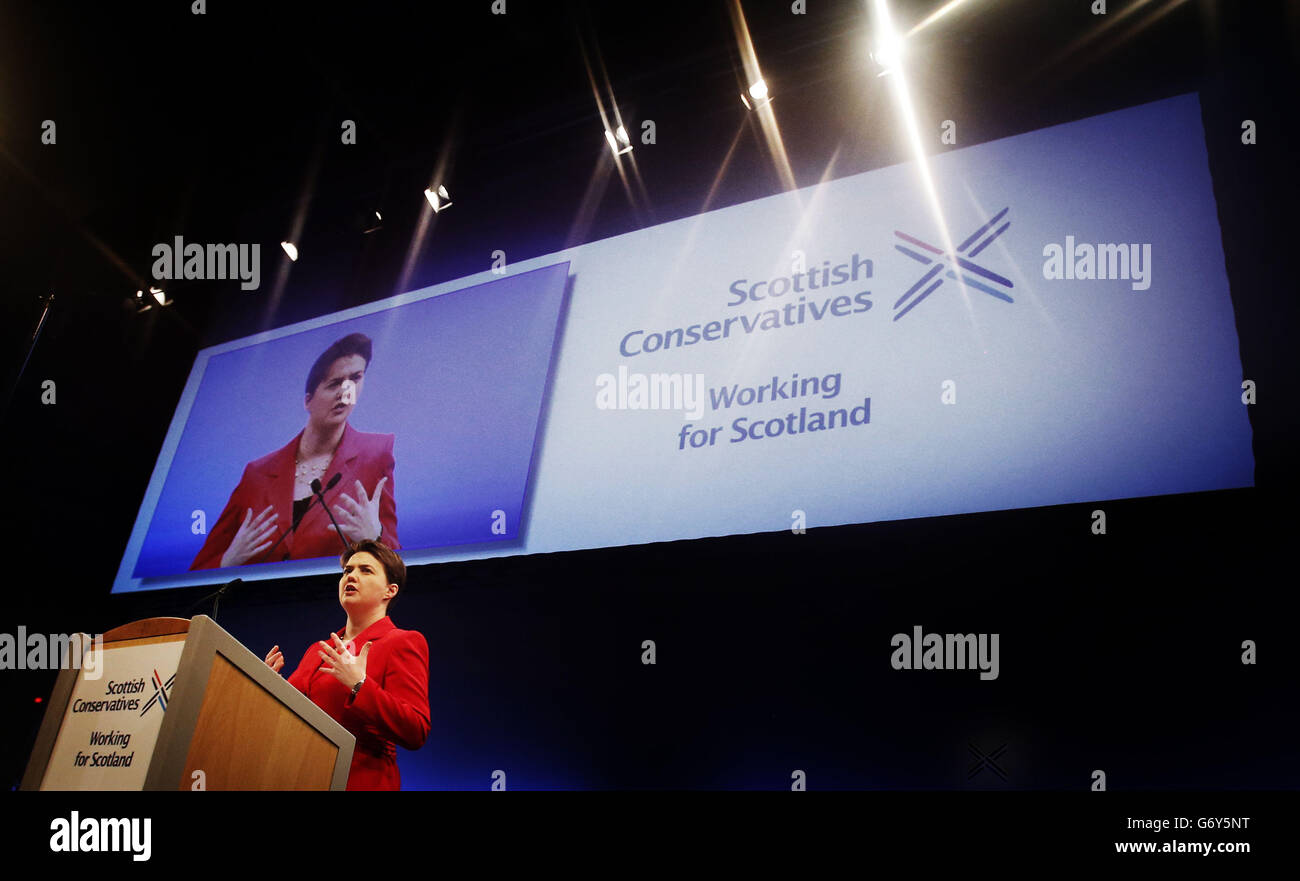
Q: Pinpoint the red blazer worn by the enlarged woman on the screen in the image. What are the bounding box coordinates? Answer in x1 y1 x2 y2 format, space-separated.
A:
190 425 402 569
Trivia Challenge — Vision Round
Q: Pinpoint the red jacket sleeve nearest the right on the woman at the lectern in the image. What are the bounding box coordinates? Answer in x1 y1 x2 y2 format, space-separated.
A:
347 630 429 750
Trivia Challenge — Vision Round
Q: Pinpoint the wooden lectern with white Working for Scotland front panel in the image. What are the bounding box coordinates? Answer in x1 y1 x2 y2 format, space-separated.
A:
22 615 355 790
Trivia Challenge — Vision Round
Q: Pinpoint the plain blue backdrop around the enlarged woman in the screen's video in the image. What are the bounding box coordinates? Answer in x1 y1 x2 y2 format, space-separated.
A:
126 264 567 577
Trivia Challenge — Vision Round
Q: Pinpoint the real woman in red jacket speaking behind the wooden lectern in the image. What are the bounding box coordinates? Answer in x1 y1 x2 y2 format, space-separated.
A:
267 541 429 790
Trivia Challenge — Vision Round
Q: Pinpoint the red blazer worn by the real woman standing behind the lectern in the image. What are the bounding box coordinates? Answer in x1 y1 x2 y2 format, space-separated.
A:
289 616 429 790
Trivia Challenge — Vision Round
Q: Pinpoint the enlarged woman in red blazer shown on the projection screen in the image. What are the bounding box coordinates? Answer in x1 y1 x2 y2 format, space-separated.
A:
190 334 400 569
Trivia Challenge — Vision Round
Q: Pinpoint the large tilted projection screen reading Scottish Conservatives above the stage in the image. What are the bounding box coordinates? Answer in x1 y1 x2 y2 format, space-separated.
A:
113 95 1255 591
